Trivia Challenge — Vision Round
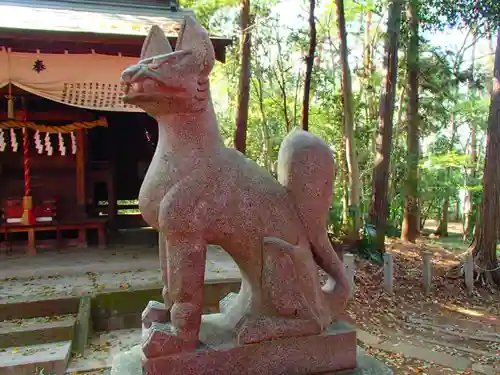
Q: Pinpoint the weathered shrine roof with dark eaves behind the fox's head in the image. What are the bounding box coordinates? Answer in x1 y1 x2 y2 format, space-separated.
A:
0 0 232 62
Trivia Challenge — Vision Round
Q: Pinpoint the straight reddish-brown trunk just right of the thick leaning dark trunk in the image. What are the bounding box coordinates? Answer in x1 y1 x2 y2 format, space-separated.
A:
401 0 420 242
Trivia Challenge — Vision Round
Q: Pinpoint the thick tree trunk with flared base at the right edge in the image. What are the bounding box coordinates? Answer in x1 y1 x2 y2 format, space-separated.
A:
471 27 500 286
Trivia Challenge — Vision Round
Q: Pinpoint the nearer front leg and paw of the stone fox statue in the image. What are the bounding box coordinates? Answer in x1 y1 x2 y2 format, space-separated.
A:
142 234 207 358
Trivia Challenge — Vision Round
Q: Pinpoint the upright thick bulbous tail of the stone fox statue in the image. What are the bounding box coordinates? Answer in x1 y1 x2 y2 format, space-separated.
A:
278 128 349 314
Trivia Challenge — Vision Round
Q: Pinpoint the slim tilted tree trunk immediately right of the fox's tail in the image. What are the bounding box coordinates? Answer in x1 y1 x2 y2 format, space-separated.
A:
335 0 361 239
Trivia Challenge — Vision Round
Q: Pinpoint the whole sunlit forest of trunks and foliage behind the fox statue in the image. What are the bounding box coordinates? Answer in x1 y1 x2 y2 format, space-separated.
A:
177 0 500 286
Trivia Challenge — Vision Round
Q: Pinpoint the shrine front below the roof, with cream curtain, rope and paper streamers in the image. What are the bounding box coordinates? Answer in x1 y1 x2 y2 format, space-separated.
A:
0 49 156 254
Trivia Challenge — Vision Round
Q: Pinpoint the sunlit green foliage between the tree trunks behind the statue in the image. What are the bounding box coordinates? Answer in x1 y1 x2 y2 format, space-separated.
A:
187 0 492 253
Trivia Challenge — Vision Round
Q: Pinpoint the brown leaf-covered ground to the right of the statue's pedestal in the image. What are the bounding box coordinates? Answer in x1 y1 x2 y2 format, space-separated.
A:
347 239 500 374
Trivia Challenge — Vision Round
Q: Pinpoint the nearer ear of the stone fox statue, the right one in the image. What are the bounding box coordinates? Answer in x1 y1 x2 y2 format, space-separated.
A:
175 16 215 76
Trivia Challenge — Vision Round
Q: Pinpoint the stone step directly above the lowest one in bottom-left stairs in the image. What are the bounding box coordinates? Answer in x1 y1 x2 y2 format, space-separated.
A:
0 315 76 350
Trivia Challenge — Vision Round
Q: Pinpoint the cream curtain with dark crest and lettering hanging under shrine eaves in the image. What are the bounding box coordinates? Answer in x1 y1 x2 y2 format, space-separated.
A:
0 52 142 112
